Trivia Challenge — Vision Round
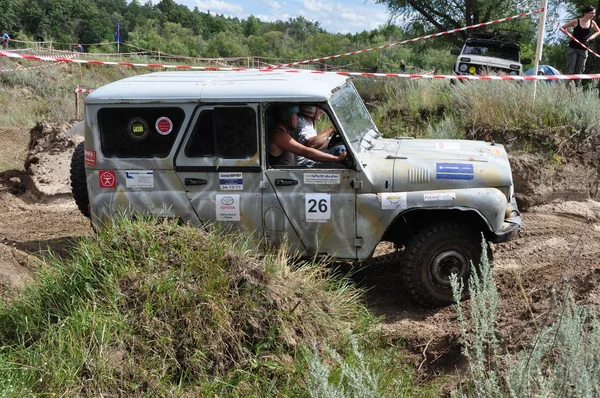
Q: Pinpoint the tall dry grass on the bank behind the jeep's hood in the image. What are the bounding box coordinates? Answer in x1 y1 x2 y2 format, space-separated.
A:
357 79 600 159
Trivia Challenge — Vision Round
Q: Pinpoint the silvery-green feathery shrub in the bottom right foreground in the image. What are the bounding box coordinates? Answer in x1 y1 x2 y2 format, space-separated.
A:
452 238 600 398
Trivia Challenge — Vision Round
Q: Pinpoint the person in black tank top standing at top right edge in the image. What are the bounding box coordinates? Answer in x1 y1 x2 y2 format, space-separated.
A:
561 5 600 85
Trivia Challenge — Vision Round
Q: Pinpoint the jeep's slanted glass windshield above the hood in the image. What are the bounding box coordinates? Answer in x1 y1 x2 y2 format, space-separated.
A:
329 84 380 151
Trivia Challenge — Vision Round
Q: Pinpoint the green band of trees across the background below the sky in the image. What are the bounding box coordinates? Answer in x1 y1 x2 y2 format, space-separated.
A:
0 0 599 73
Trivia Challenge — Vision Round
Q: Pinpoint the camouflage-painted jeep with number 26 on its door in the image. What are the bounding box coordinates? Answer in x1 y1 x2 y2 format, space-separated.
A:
71 71 521 306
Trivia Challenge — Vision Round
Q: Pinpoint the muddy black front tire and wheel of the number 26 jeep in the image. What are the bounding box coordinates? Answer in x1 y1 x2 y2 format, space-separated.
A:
401 223 481 307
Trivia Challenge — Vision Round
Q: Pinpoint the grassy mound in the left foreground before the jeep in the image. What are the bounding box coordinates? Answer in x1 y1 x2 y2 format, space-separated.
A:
0 220 439 396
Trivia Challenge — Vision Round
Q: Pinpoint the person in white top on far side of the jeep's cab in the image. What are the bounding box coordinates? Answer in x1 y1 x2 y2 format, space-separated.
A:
296 105 346 165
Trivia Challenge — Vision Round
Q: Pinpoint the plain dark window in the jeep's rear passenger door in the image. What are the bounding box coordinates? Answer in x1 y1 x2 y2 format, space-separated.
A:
185 107 258 159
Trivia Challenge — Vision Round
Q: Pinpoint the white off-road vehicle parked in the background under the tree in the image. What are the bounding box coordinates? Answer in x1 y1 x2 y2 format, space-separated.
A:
450 32 531 75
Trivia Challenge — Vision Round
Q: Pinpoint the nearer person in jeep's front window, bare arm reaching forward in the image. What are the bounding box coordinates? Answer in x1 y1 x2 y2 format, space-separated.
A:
268 105 346 166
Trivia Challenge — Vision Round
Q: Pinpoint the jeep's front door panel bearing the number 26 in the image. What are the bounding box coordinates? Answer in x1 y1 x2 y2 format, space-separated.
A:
263 104 360 259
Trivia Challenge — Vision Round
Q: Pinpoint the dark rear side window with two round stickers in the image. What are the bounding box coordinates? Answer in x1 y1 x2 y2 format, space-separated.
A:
98 108 185 158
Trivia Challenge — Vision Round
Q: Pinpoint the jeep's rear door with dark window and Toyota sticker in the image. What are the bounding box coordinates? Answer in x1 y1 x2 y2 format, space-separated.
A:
175 104 263 233
